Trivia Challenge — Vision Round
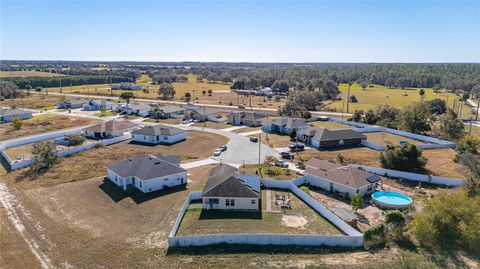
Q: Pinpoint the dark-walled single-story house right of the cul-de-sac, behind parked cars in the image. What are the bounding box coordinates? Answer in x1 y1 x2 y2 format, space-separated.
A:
297 127 367 148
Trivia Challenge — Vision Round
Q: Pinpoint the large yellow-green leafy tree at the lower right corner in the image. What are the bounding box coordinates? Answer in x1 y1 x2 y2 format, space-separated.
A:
412 190 480 253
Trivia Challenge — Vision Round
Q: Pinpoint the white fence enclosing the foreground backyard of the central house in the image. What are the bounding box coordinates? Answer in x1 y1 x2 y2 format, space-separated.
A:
168 177 363 247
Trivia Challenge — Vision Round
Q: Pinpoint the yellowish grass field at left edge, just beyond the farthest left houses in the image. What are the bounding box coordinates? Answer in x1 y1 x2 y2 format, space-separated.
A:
0 94 65 109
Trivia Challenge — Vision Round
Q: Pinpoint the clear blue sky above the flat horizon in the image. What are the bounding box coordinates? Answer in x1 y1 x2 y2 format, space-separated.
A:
0 0 480 62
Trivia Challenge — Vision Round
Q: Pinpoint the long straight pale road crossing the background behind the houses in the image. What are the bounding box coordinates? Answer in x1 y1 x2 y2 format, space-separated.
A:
31 91 352 116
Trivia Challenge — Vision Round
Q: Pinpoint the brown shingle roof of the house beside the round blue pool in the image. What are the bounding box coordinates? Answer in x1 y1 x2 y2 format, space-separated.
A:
305 158 380 186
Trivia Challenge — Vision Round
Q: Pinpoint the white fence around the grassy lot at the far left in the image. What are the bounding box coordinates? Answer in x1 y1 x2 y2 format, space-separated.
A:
0 132 132 171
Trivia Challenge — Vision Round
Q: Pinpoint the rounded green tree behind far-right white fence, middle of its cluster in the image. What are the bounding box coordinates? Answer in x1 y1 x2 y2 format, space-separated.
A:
399 103 431 134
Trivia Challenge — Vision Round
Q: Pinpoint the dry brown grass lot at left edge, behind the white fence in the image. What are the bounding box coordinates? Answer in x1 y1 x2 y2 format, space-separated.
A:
0 114 100 140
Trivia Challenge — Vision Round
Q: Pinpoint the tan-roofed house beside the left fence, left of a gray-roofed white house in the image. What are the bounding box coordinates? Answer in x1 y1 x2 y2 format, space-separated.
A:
83 120 138 139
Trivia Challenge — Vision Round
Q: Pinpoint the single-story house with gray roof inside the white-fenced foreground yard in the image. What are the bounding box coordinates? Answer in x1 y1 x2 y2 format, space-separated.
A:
202 164 261 211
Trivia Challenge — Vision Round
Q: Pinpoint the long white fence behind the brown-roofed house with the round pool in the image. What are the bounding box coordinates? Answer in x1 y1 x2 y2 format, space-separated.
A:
350 164 463 187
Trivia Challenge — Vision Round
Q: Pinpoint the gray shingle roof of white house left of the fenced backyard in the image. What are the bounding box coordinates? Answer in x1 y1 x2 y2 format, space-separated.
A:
108 155 187 180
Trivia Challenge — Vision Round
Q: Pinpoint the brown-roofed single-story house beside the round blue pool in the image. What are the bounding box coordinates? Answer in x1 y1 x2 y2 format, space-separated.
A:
304 158 380 197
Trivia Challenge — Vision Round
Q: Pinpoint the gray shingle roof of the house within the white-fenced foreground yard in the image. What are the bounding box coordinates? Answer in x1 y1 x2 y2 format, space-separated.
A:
202 164 260 198
